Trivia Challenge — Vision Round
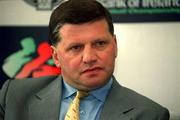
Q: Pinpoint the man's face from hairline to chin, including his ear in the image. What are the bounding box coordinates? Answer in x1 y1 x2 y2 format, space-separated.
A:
52 19 117 91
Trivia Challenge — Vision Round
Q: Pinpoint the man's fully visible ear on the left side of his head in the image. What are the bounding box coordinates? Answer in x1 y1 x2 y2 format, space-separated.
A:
51 46 60 68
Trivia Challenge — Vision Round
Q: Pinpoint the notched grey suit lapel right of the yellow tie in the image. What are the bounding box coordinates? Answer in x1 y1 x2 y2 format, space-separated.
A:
100 78 133 120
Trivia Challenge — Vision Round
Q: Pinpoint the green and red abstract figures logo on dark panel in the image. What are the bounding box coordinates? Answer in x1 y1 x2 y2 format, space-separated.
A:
2 37 61 78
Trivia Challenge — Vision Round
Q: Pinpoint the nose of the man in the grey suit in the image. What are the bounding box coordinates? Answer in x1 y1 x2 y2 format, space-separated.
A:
82 46 97 64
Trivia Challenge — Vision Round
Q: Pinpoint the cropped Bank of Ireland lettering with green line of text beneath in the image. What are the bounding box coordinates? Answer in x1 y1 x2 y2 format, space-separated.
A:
97 0 180 14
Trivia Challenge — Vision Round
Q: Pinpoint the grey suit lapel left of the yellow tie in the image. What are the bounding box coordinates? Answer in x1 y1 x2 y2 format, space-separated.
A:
29 77 61 120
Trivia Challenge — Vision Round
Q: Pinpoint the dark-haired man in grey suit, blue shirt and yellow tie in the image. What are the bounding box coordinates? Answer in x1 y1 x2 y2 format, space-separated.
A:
0 0 169 120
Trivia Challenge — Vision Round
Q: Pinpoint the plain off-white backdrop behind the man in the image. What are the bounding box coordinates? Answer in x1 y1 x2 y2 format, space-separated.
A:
0 0 180 119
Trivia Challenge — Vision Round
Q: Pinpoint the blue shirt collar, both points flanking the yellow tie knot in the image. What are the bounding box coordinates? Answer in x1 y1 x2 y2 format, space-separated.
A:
63 78 113 102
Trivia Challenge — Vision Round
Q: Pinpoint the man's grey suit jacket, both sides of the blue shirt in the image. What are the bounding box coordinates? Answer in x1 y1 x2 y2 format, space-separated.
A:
0 76 169 120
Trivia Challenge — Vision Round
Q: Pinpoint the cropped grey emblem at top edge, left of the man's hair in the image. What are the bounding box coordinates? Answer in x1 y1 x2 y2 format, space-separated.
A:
24 0 62 10
